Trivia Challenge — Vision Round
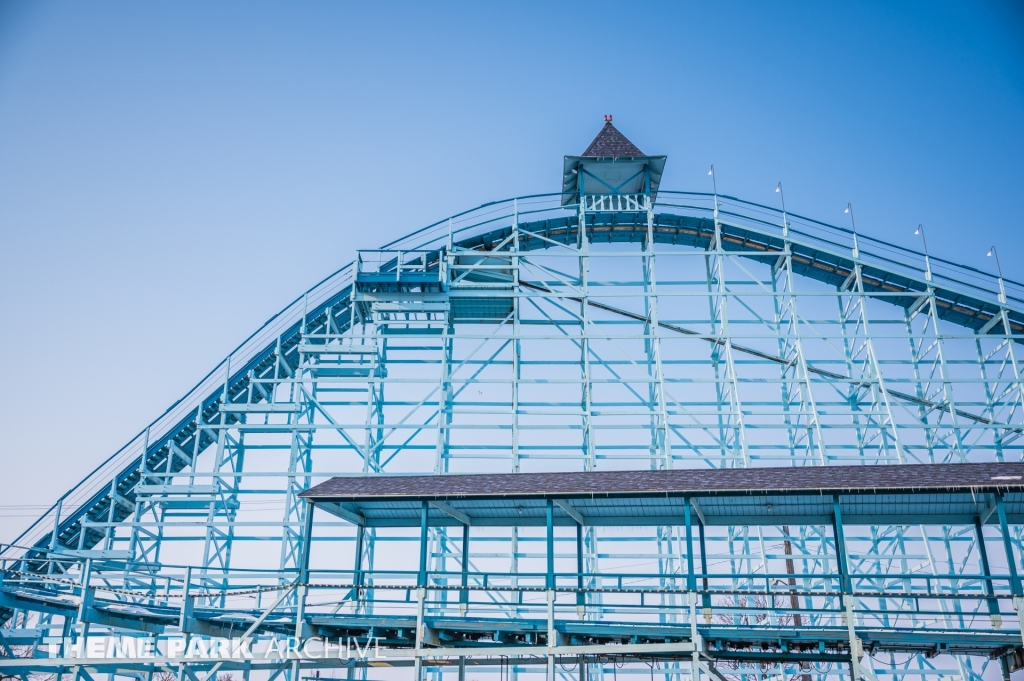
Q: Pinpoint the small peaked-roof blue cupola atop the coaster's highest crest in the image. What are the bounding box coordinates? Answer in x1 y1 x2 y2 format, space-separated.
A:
562 115 668 206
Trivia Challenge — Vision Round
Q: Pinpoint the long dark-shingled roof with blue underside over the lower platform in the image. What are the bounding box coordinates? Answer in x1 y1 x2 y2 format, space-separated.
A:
300 463 1024 527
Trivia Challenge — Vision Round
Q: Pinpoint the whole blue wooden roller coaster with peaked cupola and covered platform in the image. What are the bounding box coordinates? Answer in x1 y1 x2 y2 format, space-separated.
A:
0 120 1024 681
